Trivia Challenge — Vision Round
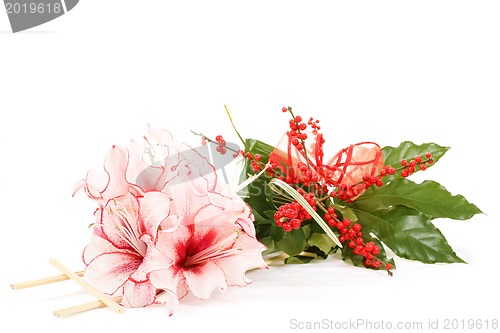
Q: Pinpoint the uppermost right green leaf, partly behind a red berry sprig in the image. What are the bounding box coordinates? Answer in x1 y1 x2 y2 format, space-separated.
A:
382 141 450 183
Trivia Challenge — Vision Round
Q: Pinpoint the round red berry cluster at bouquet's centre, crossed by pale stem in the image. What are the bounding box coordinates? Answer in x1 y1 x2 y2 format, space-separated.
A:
274 189 316 232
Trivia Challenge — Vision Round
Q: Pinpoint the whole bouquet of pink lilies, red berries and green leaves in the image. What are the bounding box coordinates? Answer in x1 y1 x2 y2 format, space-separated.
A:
13 107 481 316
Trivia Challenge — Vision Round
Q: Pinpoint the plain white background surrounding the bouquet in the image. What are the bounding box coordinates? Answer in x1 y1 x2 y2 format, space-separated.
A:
0 0 500 332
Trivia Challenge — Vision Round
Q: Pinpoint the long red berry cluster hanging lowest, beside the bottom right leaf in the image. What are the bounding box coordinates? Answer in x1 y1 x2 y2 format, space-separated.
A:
324 206 392 271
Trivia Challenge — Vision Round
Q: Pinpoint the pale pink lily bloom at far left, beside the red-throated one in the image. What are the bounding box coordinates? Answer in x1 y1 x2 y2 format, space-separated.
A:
83 192 175 307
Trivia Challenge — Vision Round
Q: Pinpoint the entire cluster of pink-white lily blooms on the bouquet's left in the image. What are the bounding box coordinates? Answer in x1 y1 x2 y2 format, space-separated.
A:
75 129 267 313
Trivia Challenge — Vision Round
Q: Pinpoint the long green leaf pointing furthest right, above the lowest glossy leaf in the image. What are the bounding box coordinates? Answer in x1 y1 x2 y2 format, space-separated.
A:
352 179 482 220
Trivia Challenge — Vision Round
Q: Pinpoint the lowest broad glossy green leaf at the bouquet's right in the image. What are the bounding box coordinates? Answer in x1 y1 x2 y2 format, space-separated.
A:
354 205 464 263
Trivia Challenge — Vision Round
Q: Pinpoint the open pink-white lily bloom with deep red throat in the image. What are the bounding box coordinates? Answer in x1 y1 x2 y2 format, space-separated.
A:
149 178 267 313
